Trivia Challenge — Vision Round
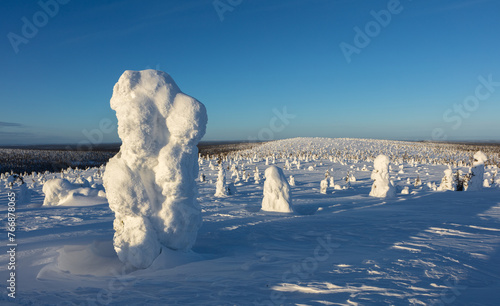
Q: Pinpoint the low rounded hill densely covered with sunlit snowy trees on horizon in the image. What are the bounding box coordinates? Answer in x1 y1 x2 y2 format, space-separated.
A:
228 138 500 168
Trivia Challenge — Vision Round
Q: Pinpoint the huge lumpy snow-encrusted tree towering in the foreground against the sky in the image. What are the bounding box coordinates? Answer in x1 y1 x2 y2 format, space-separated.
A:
103 70 207 268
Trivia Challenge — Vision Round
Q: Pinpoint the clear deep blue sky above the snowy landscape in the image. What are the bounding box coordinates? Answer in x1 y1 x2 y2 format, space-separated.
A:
0 0 500 144
